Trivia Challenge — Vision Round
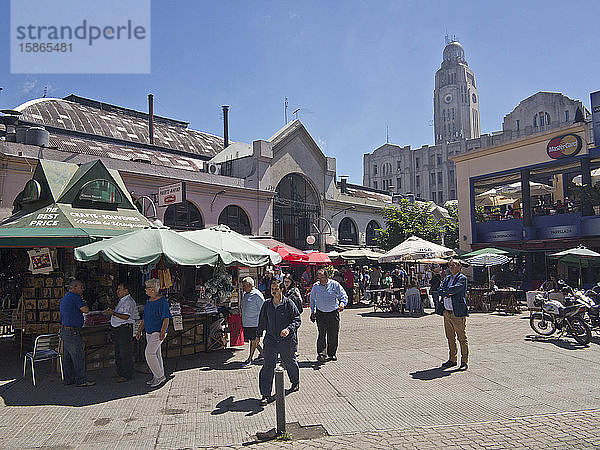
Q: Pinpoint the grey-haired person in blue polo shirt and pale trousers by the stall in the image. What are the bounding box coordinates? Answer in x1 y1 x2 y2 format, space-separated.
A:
135 278 173 387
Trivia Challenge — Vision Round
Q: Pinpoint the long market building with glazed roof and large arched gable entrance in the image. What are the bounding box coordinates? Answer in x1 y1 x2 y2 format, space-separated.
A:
0 95 400 253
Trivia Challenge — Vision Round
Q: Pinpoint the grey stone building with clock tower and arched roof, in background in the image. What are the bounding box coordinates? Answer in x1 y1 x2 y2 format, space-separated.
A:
363 36 590 204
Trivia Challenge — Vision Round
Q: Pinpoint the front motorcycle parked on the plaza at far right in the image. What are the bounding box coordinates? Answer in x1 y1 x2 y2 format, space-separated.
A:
529 293 592 345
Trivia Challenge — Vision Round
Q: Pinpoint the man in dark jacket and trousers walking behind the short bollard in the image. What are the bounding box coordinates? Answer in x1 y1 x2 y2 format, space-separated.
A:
257 278 301 406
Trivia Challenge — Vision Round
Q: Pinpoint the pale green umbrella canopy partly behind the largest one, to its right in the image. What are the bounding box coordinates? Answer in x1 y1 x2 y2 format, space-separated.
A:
181 225 281 267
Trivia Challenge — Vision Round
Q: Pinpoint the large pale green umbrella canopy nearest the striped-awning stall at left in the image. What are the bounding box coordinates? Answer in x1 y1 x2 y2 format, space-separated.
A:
75 228 231 266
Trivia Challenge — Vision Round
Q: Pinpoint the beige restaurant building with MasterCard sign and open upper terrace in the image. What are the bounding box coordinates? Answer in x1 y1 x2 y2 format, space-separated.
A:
452 93 600 288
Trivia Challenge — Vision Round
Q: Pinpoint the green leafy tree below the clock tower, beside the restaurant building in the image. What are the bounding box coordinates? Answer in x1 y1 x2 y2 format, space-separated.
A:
377 199 450 250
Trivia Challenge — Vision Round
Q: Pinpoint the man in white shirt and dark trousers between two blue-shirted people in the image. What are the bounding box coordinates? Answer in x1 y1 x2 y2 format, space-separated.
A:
104 282 139 383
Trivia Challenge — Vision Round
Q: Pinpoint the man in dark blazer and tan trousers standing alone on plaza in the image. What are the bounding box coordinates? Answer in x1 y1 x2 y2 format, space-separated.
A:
435 259 469 370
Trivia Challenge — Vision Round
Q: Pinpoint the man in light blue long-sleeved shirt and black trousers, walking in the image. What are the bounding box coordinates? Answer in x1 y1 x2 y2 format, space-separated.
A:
310 269 348 362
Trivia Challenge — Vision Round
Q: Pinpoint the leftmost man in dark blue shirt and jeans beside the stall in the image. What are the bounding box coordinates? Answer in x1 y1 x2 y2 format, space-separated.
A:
60 280 96 387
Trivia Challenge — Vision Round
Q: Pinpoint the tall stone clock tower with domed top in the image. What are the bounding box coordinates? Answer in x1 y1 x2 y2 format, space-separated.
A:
433 37 481 144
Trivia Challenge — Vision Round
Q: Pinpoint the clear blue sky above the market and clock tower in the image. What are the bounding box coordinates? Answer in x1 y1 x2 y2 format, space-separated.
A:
0 0 600 183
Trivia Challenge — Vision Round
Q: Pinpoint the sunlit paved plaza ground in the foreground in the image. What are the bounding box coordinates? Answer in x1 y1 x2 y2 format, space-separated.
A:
0 308 600 449
